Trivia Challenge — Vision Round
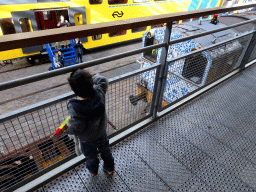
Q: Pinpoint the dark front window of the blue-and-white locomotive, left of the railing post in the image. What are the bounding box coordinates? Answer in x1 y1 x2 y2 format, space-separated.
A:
144 32 159 63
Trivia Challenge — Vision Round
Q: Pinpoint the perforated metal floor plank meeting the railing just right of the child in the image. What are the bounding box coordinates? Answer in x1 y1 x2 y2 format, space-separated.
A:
119 131 211 191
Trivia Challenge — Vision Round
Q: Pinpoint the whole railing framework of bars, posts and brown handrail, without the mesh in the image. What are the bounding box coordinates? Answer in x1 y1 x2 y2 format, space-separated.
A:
0 4 256 190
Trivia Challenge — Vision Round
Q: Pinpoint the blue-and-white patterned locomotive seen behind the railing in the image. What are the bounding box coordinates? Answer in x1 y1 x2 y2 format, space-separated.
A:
130 16 247 109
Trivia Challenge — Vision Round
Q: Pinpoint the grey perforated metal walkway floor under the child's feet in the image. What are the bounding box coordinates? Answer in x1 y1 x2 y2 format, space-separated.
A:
34 65 256 192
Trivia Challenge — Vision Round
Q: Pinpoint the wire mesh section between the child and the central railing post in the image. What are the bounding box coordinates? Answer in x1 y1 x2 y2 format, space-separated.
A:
106 69 158 135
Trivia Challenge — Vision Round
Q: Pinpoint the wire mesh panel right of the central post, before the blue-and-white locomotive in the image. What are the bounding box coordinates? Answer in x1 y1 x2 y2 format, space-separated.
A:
161 35 249 109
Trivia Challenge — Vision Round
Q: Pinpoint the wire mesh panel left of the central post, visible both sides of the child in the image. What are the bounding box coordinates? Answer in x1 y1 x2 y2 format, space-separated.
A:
0 65 158 190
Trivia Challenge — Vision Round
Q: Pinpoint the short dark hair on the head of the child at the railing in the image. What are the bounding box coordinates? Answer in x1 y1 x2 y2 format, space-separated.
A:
68 69 95 98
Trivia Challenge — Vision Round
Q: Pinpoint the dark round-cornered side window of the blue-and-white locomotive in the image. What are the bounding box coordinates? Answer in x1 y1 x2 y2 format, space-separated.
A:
182 53 207 84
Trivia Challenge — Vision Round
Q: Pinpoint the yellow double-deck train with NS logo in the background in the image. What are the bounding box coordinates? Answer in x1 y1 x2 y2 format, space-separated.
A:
0 0 224 63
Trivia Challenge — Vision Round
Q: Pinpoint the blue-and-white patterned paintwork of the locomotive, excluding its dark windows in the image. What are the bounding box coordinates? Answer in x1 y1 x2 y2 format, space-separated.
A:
140 21 241 103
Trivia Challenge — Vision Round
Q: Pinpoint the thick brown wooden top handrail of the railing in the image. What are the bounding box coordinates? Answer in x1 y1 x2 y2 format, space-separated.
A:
0 4 256 51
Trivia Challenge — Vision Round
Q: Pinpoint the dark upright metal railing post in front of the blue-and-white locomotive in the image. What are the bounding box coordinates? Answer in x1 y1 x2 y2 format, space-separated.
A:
152 22 172 118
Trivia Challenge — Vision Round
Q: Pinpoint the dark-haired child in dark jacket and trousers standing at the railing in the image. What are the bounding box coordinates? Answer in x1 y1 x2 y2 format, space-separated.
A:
66 69 114 176
